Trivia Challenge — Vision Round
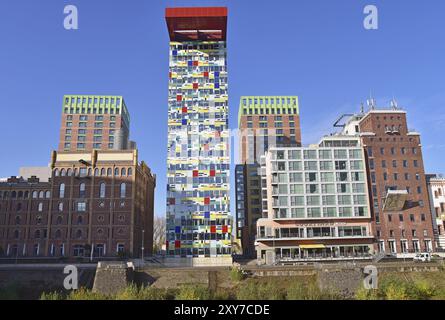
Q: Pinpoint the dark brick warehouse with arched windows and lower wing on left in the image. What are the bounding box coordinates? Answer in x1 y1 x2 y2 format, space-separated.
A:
0 150 156 258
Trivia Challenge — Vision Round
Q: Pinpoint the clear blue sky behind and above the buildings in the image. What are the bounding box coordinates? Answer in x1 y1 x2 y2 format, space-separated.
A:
0 0 445 215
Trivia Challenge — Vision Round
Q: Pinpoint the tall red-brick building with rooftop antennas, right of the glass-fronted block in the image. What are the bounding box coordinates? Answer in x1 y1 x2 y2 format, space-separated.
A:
343 101 435 256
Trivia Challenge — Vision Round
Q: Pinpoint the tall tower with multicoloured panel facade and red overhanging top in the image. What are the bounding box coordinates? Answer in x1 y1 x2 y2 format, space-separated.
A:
166 7 232 258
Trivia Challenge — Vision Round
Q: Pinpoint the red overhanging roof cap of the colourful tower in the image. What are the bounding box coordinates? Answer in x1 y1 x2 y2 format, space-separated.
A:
165 7 227 42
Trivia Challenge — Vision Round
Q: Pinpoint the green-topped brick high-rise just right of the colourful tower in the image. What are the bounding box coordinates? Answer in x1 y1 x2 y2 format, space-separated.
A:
235 96 301 257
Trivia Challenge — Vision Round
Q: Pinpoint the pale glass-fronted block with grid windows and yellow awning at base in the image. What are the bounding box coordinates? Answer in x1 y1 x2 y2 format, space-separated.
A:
256 136 374 263
